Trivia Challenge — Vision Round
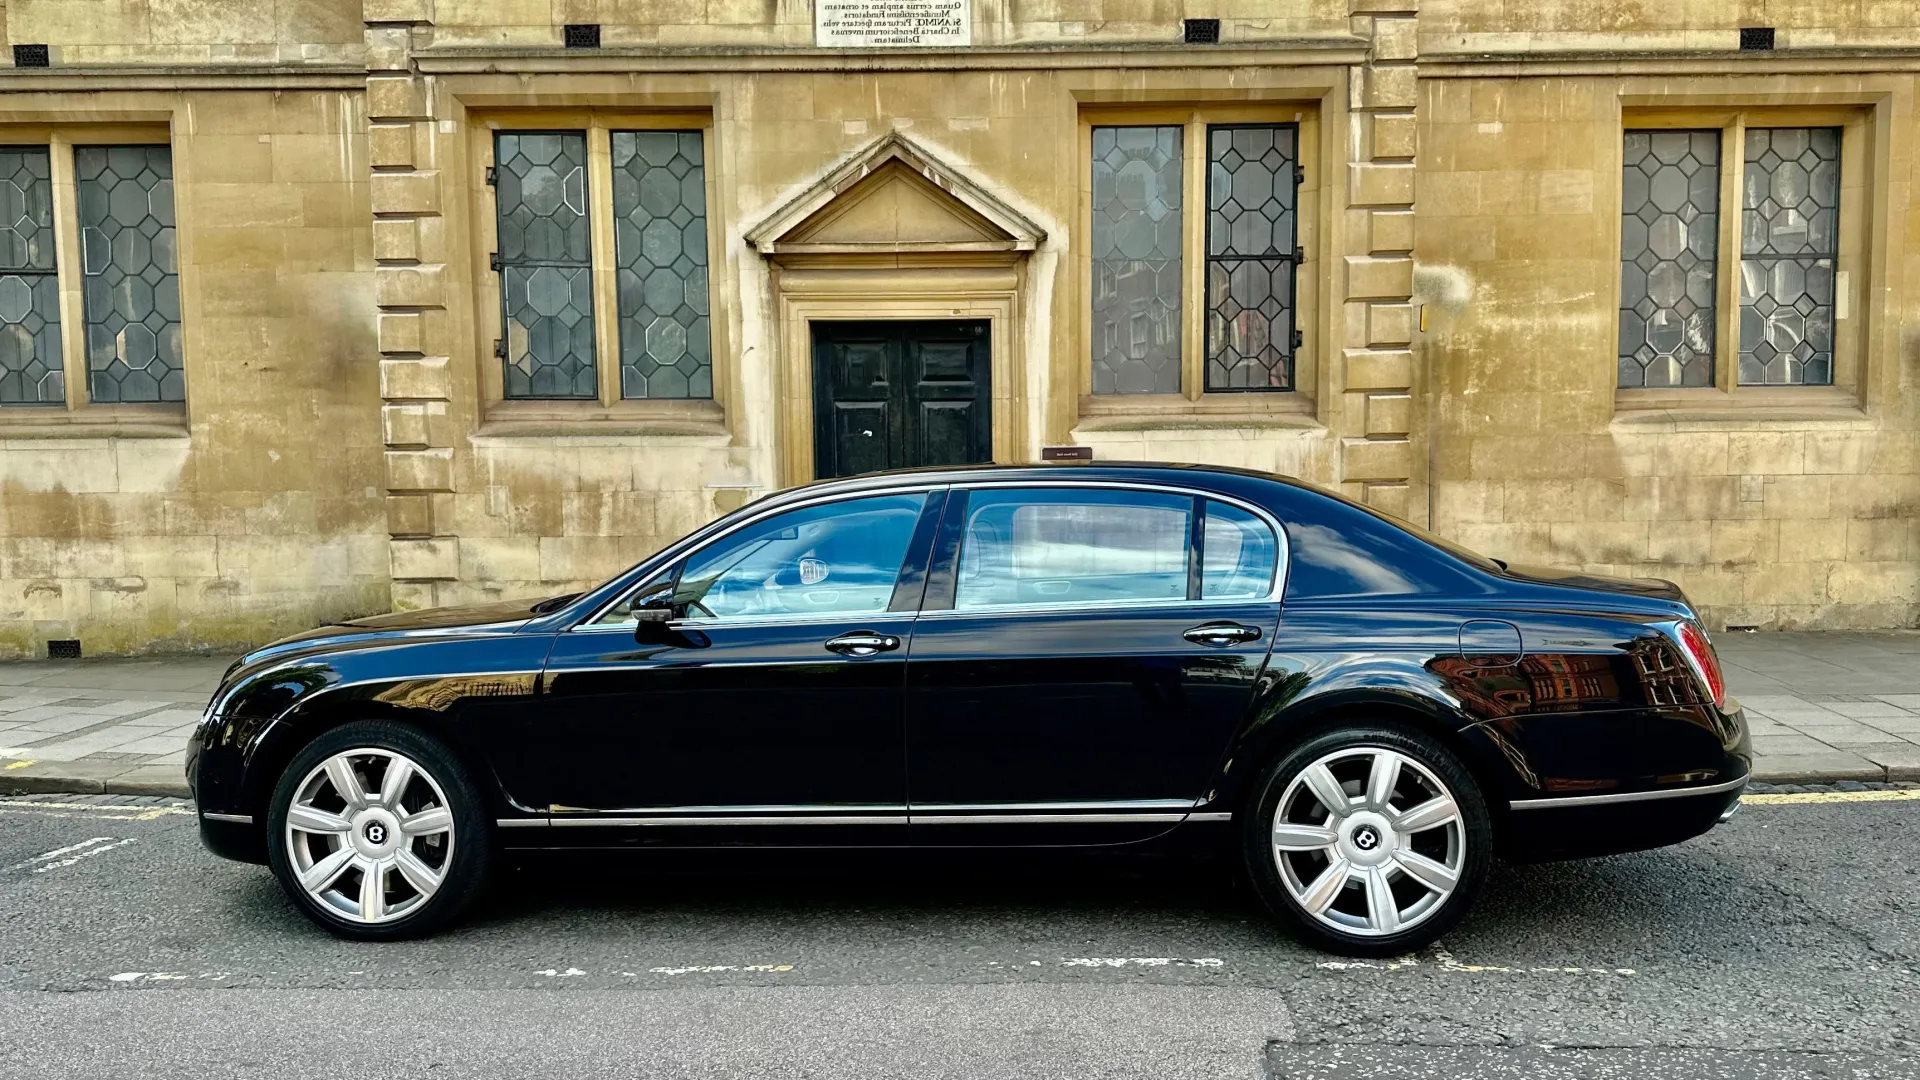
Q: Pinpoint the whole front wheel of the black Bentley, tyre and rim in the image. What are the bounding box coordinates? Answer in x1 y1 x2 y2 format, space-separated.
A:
267 721 493 942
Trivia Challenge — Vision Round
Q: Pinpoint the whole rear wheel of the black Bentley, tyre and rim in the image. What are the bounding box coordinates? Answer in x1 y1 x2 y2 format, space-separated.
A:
1244 726 1494 957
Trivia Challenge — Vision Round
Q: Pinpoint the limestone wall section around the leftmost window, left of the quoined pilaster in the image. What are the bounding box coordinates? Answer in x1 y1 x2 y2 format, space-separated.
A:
0 88 388 655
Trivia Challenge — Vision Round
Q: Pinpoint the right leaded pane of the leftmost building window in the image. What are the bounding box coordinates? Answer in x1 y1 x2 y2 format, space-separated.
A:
73 146 186 402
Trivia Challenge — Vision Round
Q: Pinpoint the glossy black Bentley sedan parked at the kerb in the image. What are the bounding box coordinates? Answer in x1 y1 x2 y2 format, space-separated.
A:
186 465 1751 955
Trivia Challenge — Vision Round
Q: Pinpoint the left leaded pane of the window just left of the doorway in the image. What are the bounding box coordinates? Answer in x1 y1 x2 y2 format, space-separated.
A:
493 131 599 398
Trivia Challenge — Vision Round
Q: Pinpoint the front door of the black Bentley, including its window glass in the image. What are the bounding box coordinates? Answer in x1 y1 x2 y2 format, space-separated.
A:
509 490 945 844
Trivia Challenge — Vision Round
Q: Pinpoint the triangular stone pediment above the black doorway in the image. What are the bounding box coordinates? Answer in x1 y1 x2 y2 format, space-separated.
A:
747 133 1046 256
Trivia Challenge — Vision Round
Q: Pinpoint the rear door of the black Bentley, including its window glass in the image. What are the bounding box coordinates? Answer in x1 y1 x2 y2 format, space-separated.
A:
906 484 1281 844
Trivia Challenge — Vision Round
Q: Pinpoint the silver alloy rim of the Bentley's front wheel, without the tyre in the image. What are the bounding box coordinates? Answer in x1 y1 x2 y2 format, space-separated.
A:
284 748 453 924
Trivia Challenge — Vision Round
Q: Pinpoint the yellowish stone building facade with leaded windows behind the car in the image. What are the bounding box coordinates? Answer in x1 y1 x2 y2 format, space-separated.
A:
0 0 1920 655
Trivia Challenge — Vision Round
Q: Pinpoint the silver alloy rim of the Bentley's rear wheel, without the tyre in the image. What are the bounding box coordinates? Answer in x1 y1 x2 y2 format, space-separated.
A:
1271 746 1467 938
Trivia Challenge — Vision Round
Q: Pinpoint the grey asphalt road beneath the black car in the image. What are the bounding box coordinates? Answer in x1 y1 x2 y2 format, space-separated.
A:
0 787 1920 1080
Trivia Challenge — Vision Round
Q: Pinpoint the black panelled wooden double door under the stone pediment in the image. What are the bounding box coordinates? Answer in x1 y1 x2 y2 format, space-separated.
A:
812 319 993 479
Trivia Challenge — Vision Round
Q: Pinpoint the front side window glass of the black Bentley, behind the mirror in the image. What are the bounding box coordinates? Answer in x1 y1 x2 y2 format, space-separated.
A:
674 494 927 619
